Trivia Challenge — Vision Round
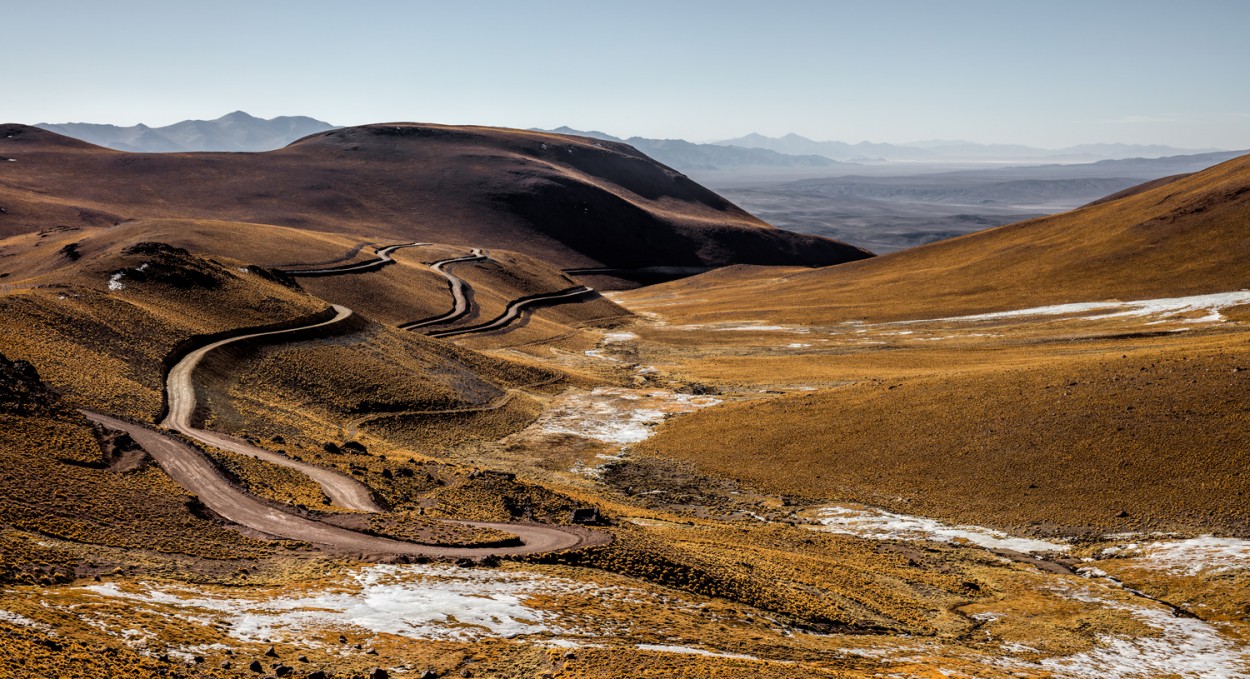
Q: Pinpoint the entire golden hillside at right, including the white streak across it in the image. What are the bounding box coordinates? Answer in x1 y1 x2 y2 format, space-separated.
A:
614 156 1250 535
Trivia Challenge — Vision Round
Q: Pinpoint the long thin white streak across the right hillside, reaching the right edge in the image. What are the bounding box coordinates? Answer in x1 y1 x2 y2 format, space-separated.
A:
920 290 1250 323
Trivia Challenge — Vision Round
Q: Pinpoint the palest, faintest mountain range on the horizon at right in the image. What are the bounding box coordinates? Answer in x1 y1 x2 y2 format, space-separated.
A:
715 134 1221 163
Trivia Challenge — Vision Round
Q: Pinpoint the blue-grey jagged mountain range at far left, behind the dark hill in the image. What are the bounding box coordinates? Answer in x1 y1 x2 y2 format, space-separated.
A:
36 111 335 153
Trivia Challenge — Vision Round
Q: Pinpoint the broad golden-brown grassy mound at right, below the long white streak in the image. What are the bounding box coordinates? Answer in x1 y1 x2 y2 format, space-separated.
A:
638 333 1250 534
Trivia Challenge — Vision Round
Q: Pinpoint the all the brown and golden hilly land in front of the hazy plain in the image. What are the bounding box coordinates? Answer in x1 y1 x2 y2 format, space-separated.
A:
0 124 1250 679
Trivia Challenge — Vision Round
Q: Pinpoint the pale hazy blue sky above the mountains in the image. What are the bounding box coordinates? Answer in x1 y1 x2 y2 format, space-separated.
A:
9 0 1250 149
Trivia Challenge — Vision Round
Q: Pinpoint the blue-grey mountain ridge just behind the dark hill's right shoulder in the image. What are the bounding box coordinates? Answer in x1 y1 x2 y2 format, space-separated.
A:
539 126 843 173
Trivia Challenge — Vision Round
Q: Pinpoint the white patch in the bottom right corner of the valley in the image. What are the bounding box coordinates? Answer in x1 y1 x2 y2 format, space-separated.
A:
1029 593 1250 679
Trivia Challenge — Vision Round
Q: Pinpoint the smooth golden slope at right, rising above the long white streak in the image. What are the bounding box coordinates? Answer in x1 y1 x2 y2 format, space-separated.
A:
620 156 1250 324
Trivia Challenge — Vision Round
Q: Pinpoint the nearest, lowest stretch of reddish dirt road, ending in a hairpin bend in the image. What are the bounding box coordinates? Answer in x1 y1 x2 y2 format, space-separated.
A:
83 410 592 558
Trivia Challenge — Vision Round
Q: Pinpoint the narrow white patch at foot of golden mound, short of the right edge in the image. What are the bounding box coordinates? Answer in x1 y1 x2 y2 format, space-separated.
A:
818 506 1068 551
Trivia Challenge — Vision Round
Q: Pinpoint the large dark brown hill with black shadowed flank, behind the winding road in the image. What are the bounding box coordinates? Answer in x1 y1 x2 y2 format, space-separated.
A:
0 124 869 277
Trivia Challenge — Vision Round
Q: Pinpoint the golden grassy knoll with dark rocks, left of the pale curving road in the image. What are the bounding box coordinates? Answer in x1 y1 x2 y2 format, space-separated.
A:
0 239 325 419
